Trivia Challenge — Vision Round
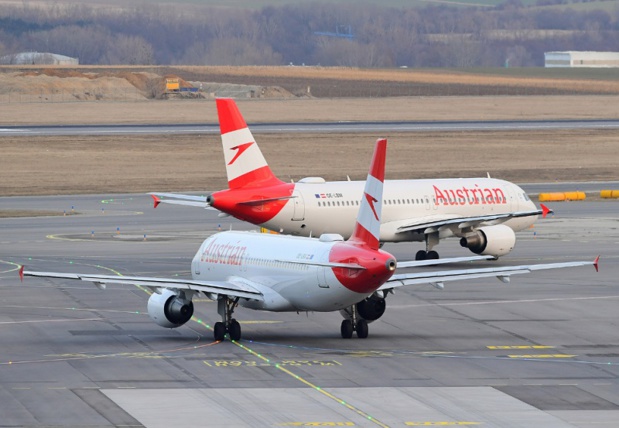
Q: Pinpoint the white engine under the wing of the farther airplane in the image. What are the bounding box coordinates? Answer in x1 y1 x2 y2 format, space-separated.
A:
460 224 516 257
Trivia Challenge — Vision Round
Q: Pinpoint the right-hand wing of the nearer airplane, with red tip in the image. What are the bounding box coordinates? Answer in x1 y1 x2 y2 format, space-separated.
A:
379 256 600 290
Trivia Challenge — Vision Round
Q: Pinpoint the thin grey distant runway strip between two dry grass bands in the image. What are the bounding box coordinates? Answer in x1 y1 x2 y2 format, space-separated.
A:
0 119 619 136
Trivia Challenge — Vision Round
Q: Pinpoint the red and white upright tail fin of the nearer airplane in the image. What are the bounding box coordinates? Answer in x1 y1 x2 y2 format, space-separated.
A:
350 138 387 250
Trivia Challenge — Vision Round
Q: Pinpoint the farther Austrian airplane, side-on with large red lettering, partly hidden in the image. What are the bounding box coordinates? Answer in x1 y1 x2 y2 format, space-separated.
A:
151 98 552 260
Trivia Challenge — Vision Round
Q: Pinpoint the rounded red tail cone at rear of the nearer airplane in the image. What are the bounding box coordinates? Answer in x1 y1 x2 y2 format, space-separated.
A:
329 243 396 294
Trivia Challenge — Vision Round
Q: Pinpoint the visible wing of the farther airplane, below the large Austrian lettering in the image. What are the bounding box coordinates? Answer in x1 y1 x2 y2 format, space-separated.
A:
397 204 552 233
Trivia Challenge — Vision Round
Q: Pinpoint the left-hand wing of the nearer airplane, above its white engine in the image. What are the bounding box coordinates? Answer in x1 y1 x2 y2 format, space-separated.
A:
19 266 263 301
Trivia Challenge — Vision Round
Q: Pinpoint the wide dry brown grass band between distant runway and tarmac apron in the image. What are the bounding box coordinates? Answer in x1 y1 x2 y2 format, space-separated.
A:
0 130 619 196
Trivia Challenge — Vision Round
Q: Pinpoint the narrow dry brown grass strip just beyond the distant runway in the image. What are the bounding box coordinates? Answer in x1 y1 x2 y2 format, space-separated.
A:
0 95 619 126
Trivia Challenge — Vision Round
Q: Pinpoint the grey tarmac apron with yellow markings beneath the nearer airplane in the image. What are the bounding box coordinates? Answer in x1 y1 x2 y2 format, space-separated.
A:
0 194 619 428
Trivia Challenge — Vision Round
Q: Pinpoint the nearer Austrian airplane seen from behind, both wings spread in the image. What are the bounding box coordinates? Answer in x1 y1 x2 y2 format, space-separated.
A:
19 139 599 341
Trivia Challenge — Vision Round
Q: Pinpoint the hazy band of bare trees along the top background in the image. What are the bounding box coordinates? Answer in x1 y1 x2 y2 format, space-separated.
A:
0 0 619 67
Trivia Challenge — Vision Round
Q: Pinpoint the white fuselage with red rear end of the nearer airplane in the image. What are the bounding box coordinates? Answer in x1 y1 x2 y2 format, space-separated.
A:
192 231 393 312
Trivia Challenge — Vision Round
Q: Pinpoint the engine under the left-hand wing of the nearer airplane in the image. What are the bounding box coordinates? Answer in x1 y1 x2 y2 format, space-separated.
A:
148 288 193 328
